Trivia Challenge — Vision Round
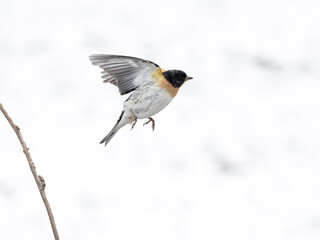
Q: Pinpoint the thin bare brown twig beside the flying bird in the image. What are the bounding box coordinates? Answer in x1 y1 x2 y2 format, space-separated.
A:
0 103 59 240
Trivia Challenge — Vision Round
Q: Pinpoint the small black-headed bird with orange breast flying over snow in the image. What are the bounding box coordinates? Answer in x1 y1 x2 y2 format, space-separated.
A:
89 54 192 146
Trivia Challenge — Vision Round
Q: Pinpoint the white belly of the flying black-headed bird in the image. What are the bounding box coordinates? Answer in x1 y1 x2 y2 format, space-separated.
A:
123 85 172 118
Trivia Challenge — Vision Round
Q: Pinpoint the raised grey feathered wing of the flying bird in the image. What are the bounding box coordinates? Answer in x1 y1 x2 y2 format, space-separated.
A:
90 54 159 95
